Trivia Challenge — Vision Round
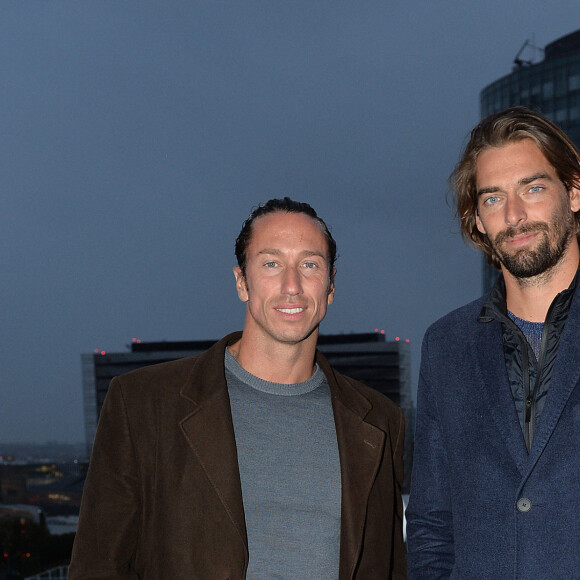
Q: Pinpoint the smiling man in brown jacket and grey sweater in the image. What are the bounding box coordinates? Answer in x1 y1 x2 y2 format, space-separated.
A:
69 198 406 580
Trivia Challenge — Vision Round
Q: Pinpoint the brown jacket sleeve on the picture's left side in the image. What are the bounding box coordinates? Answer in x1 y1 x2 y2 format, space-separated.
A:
68 378 141 580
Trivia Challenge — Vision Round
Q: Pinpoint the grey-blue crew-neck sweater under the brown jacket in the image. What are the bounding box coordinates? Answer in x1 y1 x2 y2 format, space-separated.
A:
225 351 341 580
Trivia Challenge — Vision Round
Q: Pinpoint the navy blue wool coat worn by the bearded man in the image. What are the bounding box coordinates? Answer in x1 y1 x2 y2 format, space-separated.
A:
407 283 580 580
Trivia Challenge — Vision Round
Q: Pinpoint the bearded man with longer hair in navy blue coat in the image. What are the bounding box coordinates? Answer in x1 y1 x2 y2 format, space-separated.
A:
407 107 580 580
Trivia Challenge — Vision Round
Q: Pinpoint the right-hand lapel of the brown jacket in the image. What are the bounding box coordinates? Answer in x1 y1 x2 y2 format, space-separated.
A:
317 353 386 578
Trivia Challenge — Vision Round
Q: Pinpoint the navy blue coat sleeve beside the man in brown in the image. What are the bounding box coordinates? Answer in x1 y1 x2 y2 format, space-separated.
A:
406 332 455 580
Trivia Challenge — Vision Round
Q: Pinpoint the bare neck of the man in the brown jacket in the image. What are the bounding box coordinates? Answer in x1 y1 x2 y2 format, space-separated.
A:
229 331 318 384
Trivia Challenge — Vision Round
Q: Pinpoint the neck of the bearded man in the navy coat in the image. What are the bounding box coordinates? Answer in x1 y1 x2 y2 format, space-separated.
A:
502 242 579 322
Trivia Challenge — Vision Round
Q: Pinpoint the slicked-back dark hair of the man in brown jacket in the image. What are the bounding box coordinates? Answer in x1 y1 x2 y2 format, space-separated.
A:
236 197 337 278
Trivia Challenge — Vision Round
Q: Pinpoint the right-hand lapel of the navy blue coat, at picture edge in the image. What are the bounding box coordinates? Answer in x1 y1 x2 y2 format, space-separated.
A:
530 288 580 469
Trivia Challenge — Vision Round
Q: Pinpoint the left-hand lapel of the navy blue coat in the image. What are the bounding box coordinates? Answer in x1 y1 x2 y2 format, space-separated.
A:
471 322 528 474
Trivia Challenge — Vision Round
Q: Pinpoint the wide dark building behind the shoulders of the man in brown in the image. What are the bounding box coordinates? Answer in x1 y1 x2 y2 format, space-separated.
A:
82 333 414 490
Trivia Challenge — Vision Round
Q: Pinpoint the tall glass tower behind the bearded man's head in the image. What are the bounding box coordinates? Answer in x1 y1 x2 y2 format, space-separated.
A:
480 30 580 293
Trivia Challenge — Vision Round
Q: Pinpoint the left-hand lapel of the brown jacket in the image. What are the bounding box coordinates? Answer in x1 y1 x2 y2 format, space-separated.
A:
180 334 247 548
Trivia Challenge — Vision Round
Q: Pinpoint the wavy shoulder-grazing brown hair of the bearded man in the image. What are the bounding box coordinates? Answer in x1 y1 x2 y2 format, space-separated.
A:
449 107 580 270
